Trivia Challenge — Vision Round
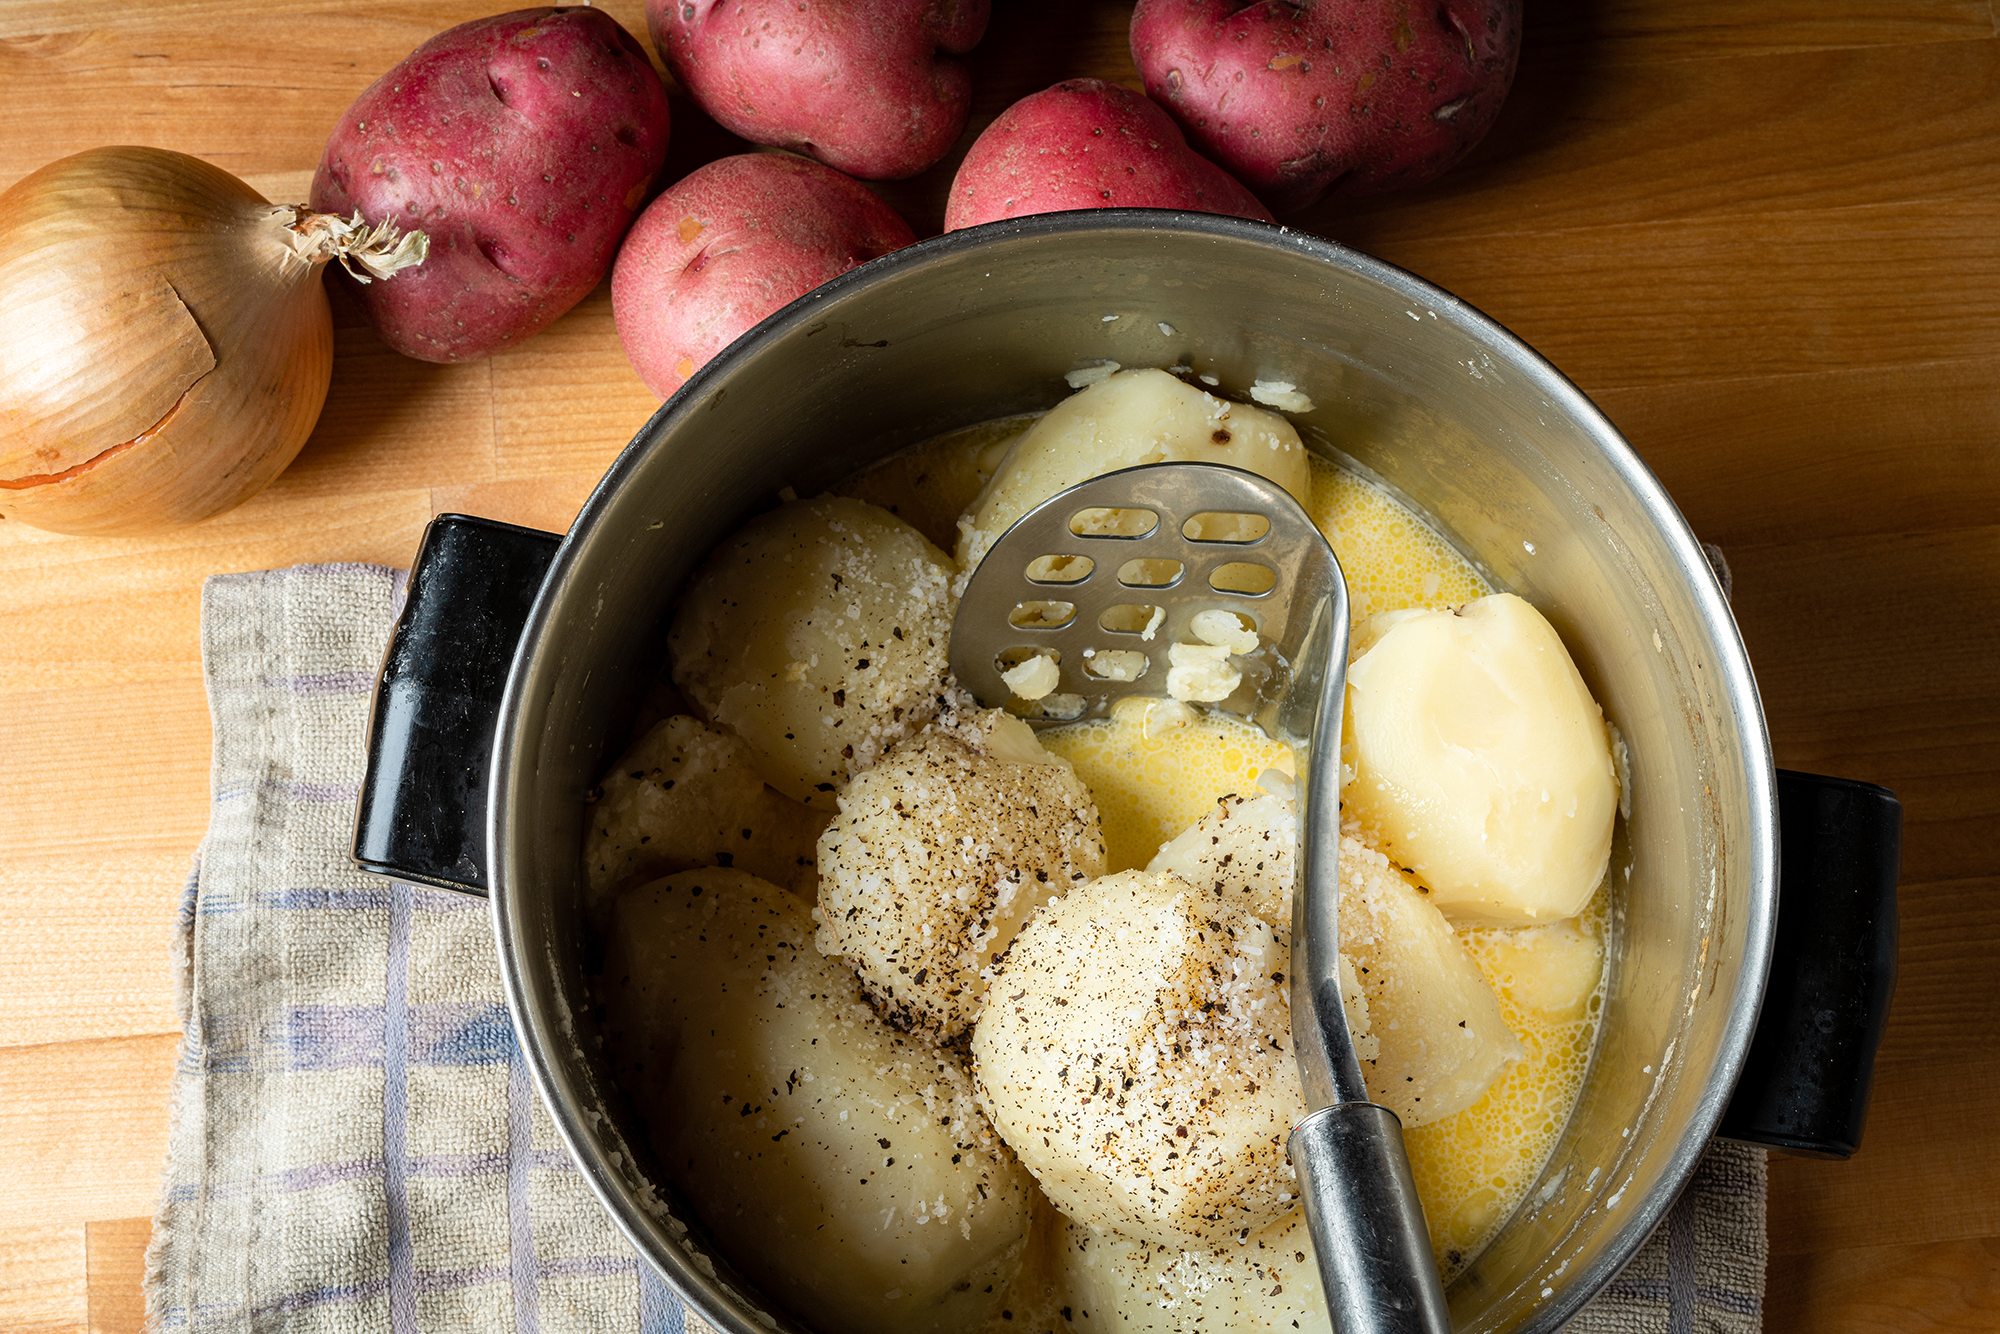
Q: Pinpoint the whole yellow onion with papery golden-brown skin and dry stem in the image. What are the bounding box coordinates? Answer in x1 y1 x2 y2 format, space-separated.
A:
0 148 426 534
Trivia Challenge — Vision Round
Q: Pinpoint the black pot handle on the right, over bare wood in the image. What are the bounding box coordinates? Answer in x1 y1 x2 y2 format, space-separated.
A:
1718 770 1902 1158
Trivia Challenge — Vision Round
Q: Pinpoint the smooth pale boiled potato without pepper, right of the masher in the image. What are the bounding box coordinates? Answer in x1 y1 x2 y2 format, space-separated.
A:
1342 594 1618 926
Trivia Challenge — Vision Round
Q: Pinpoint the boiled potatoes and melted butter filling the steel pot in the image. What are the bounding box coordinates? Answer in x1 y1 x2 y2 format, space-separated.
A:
586 370 1618 1334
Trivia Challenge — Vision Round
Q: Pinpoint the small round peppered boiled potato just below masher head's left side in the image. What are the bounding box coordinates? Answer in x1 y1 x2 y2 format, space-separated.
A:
814 708 1104 1040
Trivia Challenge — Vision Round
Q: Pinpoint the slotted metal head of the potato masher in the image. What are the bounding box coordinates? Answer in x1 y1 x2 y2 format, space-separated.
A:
952 464 1348 742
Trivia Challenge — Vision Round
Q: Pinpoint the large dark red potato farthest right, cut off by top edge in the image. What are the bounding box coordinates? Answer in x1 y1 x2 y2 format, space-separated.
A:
1132 0 1522 214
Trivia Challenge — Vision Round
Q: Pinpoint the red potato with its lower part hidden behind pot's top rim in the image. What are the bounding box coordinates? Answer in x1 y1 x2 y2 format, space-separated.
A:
944 78 1272 232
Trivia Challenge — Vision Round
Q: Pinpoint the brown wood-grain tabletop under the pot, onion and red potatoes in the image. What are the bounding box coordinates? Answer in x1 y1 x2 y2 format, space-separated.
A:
0 0 2000 1334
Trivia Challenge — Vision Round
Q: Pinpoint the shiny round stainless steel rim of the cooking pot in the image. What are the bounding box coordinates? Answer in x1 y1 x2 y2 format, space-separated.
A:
486 208 1778 1334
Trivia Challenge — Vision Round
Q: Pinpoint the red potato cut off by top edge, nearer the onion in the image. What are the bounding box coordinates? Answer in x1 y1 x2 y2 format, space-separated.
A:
646 0 992 180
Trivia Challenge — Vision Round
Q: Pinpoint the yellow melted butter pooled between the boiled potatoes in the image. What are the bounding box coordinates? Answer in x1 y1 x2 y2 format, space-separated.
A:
1040 458 1606 1278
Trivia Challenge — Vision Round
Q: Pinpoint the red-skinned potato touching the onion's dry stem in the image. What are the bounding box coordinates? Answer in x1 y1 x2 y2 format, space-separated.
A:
312 8 668 362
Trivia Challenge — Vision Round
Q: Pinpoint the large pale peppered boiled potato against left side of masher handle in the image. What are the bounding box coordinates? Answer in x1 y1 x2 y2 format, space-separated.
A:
972 872 1306 1246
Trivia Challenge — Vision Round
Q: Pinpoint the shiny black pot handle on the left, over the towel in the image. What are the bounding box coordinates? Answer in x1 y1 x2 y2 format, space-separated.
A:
354 514 562 898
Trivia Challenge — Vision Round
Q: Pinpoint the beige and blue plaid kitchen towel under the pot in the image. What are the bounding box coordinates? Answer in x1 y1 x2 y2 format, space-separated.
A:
146 566 1764 1334
